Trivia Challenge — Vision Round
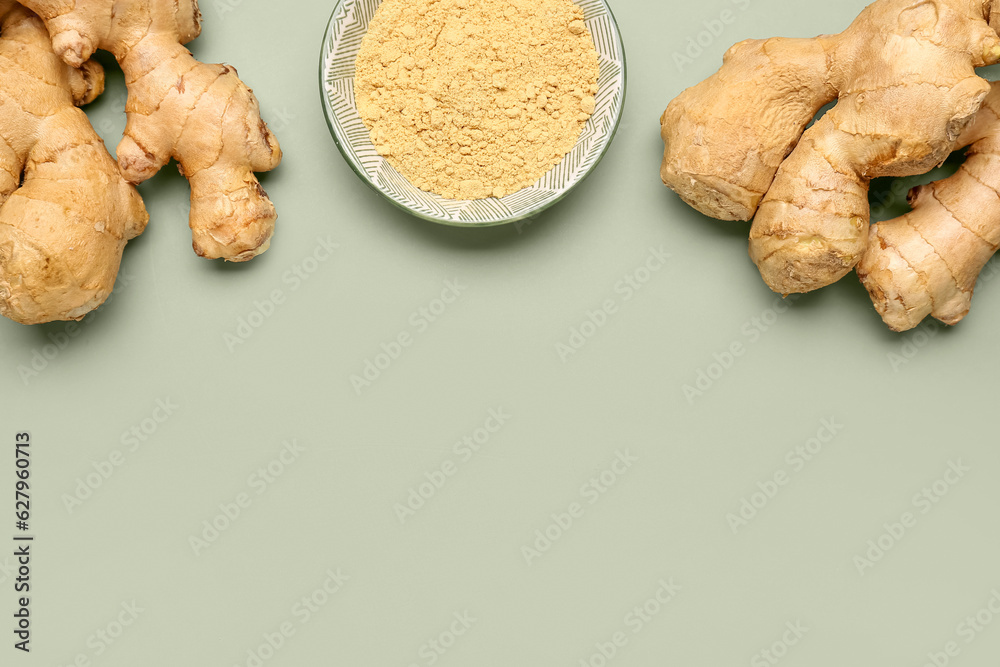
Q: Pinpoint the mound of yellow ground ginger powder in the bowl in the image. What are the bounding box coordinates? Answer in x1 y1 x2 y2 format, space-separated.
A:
355 0 599 199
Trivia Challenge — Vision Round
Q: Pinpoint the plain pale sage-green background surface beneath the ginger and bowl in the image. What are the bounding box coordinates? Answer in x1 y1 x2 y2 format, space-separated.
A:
0 0 1000 667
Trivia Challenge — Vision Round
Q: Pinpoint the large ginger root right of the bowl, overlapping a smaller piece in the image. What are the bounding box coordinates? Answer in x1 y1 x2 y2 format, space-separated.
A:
661 0 1000 294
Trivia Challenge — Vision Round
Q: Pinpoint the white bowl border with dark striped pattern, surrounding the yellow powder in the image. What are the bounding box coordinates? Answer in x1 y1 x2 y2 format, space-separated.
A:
320 0 626 227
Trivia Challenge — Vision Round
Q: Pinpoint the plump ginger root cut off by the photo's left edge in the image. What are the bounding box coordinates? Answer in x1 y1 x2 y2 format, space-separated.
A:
0 0 148 324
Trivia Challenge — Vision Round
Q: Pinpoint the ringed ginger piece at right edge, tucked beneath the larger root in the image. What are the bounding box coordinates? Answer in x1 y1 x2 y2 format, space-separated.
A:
858 83 1000 331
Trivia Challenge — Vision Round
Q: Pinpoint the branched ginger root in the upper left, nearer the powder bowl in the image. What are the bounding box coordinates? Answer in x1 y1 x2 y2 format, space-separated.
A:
20 0 281 262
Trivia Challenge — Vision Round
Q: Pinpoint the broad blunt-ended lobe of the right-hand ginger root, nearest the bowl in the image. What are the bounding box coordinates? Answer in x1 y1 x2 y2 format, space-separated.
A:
660 37 837 220
